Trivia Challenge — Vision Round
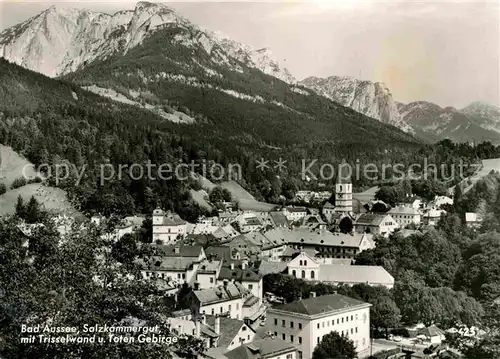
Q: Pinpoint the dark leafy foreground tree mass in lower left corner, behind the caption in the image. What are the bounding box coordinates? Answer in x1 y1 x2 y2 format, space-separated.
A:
0 217 201 359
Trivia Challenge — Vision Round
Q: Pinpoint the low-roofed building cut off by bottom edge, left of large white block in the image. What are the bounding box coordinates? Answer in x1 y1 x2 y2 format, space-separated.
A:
222 337 298 359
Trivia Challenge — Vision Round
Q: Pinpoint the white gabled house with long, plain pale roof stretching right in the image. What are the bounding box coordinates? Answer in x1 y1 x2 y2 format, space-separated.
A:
287 252 394 289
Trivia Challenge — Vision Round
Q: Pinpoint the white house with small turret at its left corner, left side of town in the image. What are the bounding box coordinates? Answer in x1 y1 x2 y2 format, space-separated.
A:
153 208 187 244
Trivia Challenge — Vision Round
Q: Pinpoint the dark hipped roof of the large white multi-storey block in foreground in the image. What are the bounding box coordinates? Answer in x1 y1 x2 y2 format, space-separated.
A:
270 294 370 316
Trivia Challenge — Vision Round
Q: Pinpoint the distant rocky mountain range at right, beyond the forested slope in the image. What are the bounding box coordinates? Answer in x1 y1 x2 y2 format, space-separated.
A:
299 76 500 144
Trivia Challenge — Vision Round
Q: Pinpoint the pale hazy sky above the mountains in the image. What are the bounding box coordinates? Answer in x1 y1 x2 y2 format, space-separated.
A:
0 0 500 108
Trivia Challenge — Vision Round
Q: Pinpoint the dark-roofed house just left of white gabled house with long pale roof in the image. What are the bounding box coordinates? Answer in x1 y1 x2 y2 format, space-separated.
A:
217 260 263 306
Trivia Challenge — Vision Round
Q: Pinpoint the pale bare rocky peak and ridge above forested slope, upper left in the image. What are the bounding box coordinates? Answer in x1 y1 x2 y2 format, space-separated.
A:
0 1 295 83
